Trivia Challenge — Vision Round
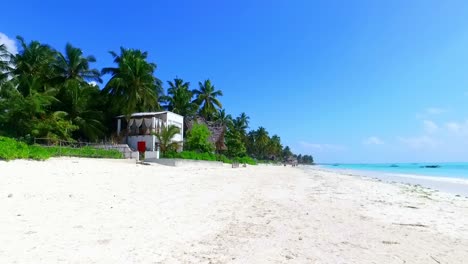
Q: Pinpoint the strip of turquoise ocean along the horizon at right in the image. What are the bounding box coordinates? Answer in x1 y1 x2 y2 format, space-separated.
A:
321 162 468 179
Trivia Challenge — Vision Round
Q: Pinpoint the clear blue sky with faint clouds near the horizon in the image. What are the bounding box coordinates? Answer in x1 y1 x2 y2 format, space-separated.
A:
0 0 468 162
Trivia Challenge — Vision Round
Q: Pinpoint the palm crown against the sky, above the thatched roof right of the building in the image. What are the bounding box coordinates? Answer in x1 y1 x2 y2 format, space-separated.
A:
193 80 223 120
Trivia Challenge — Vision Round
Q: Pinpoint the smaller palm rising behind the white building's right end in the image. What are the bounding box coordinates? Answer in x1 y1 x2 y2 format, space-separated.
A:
164 78 198 117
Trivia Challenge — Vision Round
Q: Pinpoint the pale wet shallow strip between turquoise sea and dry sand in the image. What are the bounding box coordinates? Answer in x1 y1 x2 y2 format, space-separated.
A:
314 165 468 197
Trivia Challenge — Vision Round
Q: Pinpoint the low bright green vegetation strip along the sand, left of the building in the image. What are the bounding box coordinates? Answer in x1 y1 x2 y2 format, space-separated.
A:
0 137 122 160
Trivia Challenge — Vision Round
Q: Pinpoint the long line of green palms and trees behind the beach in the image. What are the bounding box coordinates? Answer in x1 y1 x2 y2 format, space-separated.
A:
0 36 313 164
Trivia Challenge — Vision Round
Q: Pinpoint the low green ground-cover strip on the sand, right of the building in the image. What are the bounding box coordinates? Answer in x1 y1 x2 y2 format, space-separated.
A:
162 151 257 165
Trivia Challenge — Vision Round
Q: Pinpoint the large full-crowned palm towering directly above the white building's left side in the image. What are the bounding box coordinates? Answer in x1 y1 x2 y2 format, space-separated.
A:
101 47 162 115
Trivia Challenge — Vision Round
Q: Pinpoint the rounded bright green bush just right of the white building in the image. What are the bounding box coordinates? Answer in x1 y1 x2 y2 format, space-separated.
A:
184 123 215 153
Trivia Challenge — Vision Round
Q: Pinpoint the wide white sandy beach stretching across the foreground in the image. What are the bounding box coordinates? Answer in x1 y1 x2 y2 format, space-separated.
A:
0 159 468 264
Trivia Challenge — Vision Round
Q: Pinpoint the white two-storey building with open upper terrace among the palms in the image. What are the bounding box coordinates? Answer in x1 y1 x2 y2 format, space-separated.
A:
117 111 184 151
